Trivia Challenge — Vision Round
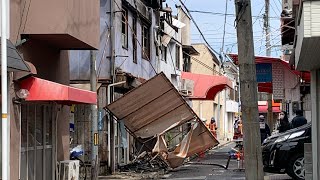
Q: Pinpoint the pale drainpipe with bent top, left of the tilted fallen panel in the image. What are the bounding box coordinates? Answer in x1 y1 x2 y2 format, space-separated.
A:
107 81 126 172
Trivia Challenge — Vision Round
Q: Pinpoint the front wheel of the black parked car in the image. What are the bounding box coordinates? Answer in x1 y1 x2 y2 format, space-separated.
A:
287 154 305 180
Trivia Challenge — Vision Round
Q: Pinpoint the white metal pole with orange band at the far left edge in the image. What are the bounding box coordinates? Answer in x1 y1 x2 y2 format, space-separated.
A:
1 0 10 180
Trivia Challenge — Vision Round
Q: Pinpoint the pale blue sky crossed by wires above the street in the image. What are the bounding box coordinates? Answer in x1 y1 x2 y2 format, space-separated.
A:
167 0 282 57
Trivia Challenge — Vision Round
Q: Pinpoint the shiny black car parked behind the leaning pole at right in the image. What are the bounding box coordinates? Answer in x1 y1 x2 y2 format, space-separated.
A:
262 123 311 180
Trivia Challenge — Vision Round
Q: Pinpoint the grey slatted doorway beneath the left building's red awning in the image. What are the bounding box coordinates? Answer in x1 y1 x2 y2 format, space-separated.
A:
20 103 56 180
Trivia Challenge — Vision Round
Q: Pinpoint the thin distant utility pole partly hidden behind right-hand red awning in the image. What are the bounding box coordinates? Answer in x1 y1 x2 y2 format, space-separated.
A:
263 0 273 129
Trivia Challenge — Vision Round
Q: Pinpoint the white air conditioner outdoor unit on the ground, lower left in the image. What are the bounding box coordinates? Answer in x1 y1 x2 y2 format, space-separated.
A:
59 160 79 180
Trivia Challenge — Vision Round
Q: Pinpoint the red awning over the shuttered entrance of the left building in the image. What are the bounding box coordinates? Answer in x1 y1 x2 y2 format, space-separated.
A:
20 77 97 104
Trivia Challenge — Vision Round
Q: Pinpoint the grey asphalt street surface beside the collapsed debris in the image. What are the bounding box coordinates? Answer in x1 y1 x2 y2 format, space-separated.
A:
163 143 291 180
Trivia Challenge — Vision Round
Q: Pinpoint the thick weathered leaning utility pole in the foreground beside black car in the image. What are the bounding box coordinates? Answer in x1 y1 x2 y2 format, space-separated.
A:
235 0 264 180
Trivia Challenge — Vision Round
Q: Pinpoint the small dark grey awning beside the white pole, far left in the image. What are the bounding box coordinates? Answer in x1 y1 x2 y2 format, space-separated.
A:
0 40 30 72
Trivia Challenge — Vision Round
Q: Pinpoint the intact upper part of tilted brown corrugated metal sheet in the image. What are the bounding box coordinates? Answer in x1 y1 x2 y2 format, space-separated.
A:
106 72 196 138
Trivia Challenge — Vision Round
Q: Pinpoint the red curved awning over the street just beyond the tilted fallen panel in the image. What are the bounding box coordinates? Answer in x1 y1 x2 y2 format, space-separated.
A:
181 72 232 100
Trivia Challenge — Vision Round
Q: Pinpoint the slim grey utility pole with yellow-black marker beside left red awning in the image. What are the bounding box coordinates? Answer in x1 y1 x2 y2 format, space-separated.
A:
90 50 99 180
